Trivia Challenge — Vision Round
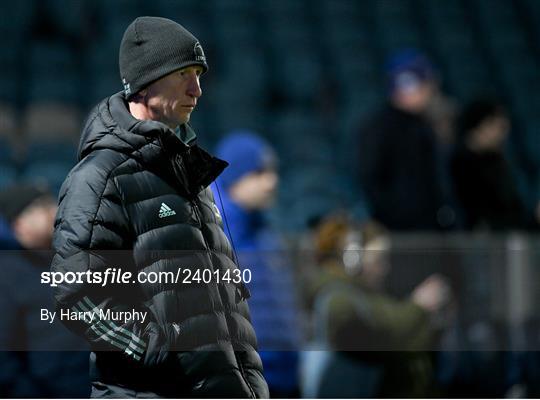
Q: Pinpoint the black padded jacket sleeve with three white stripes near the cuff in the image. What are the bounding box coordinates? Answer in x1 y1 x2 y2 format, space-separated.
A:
51 157 175 365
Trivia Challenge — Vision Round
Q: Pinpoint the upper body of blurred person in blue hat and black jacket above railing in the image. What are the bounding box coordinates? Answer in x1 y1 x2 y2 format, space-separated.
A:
358 50 455 230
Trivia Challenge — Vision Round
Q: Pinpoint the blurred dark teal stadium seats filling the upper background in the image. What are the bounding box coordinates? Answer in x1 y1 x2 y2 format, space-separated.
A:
0 0 540 231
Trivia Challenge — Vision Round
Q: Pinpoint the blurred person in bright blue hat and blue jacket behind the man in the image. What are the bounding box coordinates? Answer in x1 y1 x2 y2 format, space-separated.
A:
214 131 300 398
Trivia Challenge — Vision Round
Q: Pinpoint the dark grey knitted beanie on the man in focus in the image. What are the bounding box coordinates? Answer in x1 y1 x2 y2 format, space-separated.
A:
119 17 208 98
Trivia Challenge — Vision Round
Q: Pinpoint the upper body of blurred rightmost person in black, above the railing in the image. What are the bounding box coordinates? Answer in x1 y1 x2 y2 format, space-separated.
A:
451 100 534 230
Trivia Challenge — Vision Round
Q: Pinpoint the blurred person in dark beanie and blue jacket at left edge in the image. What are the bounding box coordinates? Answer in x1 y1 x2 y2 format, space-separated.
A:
0 184 89 398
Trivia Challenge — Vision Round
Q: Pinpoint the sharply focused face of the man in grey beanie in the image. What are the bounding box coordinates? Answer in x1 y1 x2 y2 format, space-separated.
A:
141 66 203 128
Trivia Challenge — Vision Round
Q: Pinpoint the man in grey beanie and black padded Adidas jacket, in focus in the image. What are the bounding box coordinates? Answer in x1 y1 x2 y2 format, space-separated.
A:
52 17 268 398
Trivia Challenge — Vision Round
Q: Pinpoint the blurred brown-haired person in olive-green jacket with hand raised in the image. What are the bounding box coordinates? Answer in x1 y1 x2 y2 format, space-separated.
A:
307 216 451 398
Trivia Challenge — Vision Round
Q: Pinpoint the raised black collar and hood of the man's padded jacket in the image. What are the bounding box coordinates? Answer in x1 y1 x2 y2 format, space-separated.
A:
80 92 228 197
